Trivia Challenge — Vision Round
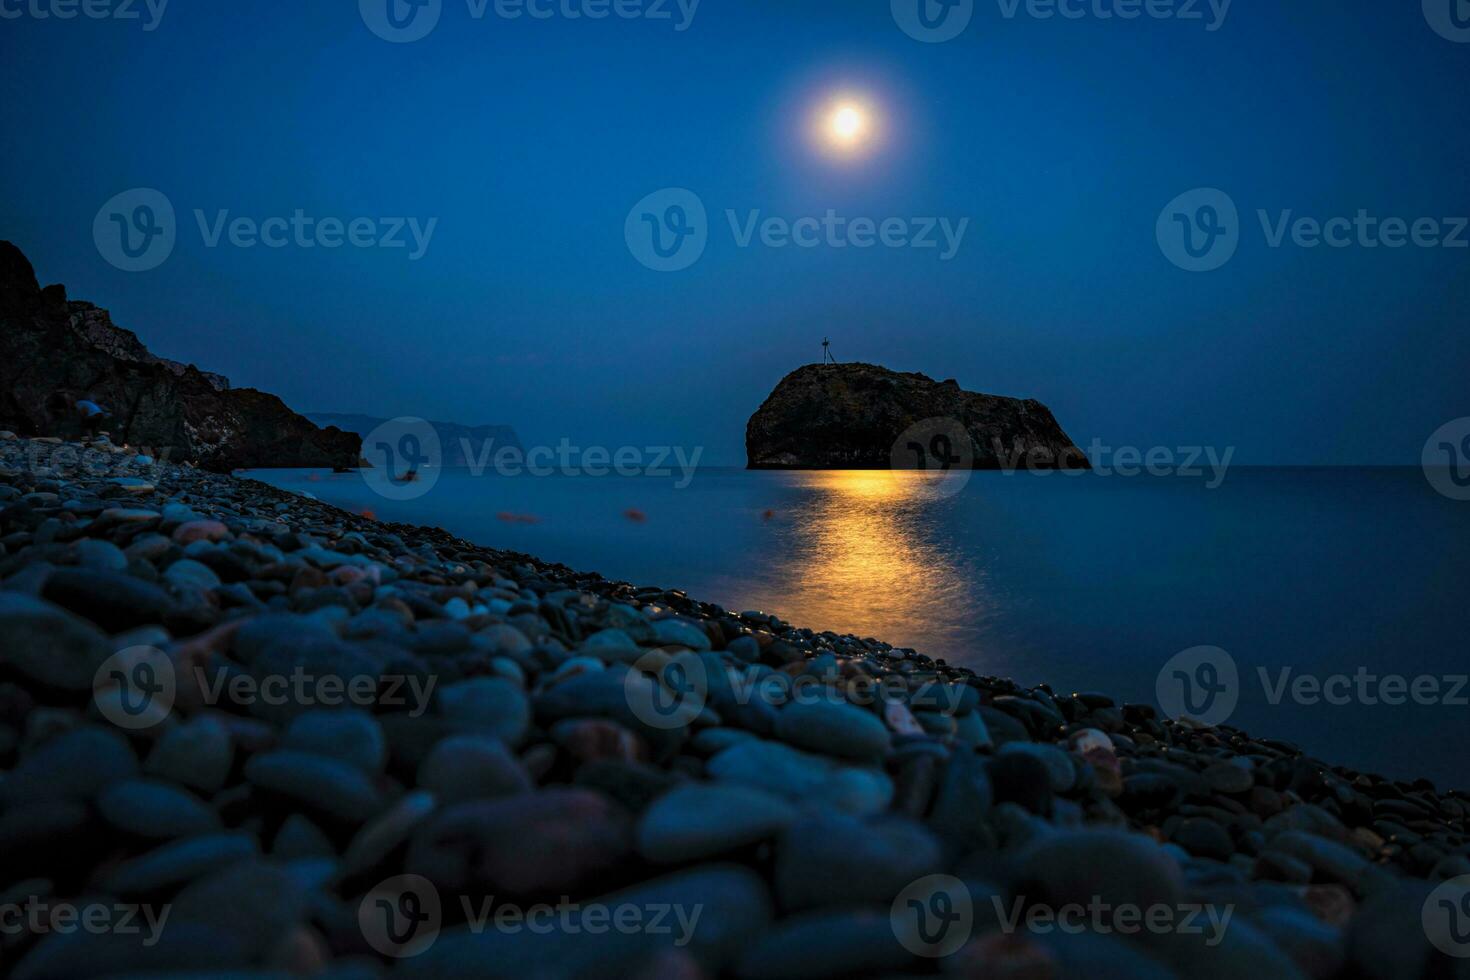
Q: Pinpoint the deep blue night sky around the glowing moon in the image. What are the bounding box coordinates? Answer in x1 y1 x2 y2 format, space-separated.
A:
0 0 1470 464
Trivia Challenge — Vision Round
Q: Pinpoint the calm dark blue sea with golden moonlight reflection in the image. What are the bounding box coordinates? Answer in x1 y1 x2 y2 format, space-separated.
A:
250 467 1470 786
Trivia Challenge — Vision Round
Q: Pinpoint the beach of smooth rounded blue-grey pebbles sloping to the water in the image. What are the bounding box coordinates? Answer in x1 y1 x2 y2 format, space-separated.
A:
0 438 1470 977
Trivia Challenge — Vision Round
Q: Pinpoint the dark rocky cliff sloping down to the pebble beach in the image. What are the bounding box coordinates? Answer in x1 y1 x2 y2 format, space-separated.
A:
0 241 362 472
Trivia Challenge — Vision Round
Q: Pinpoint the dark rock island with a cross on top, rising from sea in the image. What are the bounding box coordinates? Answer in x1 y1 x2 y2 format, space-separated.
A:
745 364 1088 470
